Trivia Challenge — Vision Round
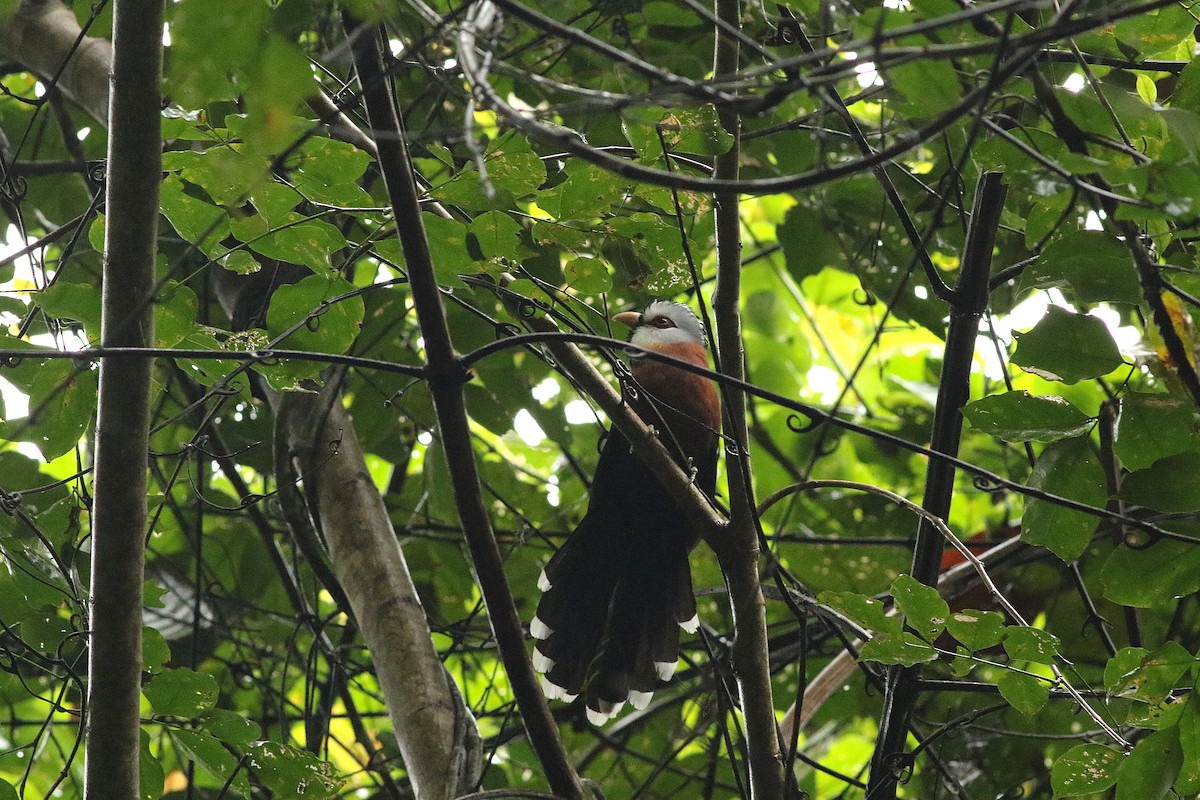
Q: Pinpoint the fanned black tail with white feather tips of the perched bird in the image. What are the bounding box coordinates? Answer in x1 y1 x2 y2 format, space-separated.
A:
529 515 698 724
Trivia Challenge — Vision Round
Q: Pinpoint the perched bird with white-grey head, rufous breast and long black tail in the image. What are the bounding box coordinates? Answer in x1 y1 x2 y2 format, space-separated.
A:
529 300 721 724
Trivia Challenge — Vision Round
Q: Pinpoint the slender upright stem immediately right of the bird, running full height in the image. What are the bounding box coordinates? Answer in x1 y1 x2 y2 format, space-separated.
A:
713 0 784 800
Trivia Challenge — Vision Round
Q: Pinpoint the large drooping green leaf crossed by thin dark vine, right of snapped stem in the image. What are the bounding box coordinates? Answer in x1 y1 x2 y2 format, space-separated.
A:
1021 439 1108 561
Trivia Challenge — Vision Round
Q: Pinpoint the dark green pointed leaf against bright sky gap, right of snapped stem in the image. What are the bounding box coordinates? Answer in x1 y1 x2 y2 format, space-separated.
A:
1013 306 1124 384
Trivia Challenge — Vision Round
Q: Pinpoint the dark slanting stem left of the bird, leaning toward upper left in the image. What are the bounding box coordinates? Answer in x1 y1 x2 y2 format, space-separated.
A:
346 19 583 799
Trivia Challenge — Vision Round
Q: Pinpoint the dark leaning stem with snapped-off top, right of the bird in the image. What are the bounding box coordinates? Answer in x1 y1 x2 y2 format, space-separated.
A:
868 173 1007 800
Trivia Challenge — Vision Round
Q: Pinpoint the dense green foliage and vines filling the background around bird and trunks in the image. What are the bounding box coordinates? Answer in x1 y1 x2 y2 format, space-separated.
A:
0 0 1200 800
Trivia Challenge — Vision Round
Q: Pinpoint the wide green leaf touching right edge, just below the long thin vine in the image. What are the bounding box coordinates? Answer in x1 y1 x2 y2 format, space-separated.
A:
1100 539 1200 608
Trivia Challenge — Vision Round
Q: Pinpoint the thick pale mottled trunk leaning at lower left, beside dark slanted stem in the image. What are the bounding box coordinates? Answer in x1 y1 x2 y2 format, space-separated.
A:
274 391 482 800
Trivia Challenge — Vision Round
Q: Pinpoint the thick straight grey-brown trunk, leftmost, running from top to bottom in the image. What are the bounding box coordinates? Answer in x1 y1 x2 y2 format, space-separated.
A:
84 0 163 800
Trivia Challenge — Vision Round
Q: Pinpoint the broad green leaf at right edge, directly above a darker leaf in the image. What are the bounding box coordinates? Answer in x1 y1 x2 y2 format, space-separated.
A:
1112 392 1200 470
